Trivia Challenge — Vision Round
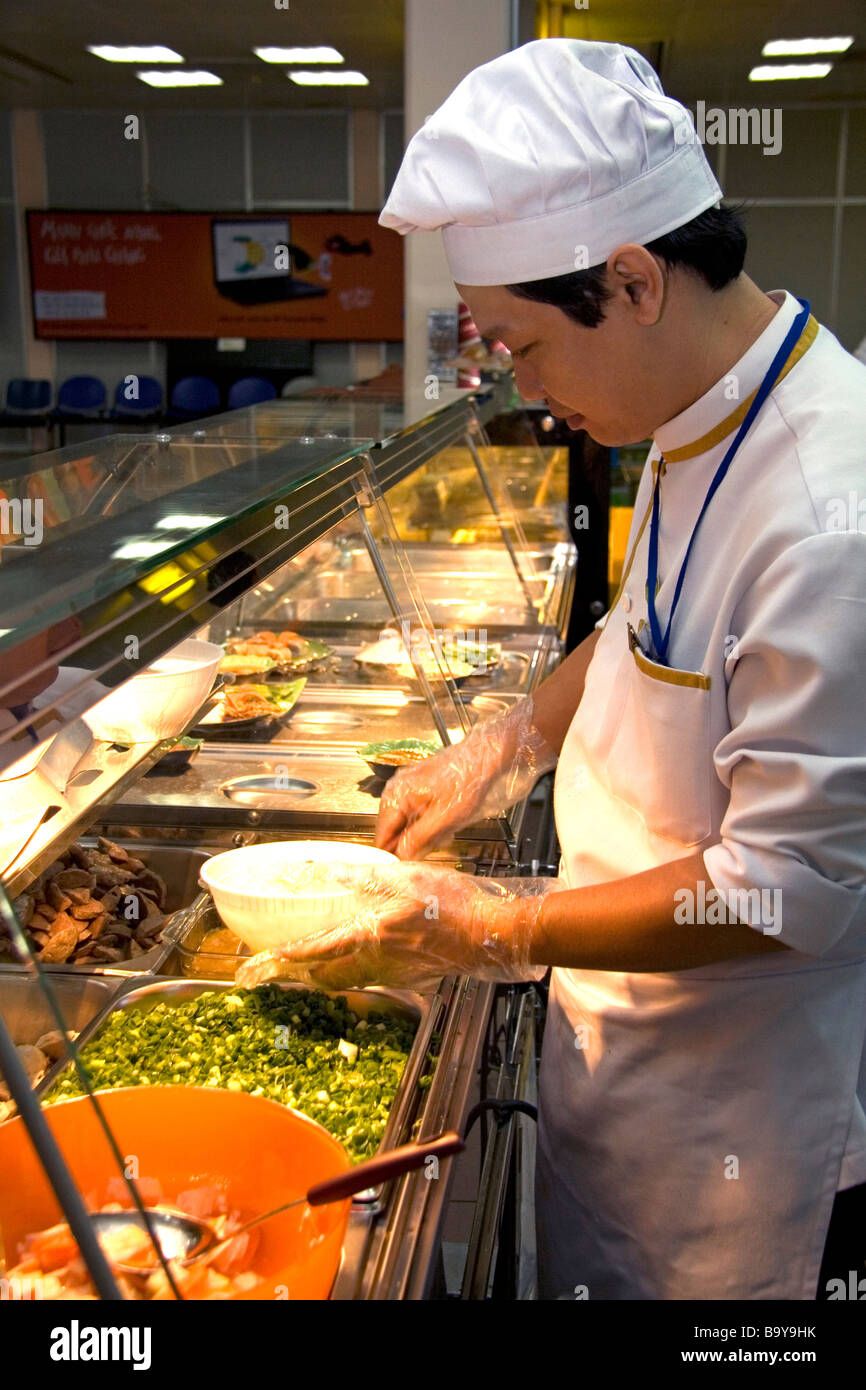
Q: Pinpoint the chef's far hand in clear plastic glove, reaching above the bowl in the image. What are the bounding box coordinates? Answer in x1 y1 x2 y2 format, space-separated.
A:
375 695 556 859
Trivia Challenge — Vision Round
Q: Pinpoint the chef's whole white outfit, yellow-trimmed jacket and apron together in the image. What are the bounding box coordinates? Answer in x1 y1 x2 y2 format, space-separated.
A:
537 291 866 1298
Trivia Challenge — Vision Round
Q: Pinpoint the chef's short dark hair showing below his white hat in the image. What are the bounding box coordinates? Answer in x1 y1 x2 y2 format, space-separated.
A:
506 207 746 328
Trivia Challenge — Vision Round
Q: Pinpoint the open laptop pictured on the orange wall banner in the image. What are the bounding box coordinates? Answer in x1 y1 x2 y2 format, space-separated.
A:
211 217 328 304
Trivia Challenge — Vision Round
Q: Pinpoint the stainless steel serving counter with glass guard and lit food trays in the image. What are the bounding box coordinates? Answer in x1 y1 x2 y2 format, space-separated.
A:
0 384 575 1300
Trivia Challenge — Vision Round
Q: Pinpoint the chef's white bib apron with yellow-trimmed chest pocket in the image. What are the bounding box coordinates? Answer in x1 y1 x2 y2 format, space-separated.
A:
537 296 866 1300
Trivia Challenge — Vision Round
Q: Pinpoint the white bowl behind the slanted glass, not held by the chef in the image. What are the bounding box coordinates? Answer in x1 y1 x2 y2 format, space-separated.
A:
86 637 225 744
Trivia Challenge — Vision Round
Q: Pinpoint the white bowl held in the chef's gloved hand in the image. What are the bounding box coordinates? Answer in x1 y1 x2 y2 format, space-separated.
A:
199 840 396 952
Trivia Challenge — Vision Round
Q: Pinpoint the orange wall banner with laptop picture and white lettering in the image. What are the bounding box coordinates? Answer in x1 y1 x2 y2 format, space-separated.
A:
26 210 403 342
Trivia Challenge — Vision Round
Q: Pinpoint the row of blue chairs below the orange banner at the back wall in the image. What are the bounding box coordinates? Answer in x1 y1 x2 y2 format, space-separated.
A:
0 374 283 425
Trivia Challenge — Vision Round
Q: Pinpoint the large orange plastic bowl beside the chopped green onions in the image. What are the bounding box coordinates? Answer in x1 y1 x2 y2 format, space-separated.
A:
0 1086 352 1301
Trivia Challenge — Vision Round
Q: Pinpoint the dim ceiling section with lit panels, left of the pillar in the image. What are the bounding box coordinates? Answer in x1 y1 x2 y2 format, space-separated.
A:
0 0 405 111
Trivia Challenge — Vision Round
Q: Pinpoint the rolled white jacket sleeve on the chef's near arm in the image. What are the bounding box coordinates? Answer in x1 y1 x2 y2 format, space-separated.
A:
703 531 866 956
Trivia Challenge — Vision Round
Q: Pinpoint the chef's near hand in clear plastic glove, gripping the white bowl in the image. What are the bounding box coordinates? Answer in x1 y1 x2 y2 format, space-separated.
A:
235 863 560 990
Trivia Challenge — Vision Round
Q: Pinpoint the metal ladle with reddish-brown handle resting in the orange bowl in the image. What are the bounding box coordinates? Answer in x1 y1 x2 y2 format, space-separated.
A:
90 1130 466 1275
